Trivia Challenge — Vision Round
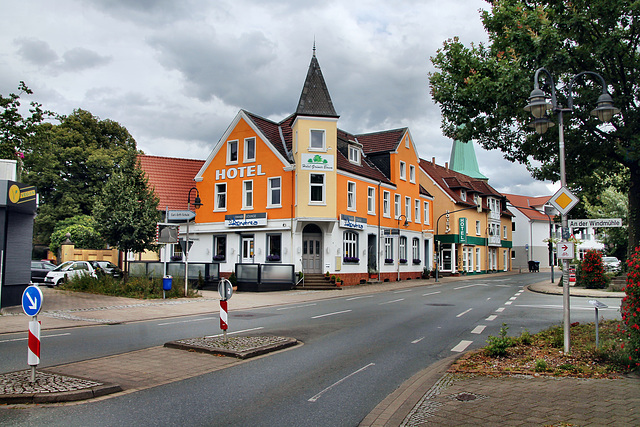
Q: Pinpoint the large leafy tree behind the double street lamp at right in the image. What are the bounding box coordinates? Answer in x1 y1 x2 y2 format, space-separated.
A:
429 0 640 258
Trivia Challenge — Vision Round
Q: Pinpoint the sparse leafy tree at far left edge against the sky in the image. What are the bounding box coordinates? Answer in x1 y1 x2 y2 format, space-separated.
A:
0 81 53 160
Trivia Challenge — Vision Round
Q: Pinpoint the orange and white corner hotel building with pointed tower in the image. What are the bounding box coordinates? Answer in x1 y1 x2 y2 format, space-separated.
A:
181 52 434 285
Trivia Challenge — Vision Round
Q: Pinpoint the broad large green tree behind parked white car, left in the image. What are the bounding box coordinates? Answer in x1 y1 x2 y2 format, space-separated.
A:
23 110 136 244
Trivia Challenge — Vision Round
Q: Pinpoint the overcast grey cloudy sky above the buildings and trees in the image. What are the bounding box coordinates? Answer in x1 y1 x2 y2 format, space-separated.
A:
0 0 557 196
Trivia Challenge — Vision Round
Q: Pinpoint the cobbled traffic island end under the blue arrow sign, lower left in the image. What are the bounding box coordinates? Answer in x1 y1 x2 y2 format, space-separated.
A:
0 370 122 404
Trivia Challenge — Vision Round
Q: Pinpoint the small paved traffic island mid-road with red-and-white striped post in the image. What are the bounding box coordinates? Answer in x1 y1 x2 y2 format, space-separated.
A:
164 336 298 359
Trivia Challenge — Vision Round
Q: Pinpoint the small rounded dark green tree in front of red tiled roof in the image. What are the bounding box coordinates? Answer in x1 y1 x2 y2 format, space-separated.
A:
93 156 160 274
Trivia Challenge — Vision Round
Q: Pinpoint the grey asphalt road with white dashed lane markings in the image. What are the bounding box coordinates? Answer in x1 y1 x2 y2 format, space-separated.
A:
0 275 619 426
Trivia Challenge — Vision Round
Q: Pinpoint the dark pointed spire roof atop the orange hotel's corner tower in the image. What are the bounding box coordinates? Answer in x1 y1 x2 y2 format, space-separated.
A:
296 47 339 117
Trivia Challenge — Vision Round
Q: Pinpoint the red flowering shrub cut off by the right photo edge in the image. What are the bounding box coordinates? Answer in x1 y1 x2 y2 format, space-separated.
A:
620 246 640 368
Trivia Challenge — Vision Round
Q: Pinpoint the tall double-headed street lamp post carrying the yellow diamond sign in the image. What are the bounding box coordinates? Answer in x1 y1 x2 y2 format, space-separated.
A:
524 68 620 353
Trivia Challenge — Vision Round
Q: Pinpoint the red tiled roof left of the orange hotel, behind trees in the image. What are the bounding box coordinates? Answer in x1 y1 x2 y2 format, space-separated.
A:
138 154 204 210
